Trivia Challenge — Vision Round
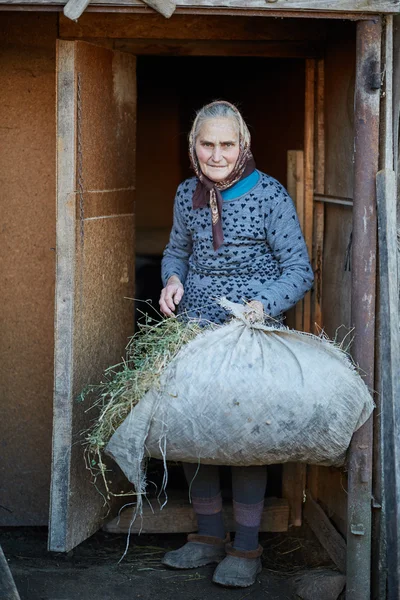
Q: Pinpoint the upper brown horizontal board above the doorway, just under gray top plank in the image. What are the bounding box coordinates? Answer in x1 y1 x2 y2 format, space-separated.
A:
59 12 326 42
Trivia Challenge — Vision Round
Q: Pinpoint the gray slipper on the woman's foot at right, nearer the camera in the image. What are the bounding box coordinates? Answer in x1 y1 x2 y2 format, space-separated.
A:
213 544 263 587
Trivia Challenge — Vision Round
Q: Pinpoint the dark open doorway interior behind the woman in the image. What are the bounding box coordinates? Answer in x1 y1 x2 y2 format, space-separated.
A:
135 56 305 326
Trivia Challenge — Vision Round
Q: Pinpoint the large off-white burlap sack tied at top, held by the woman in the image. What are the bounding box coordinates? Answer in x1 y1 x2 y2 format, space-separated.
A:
106 301 374 489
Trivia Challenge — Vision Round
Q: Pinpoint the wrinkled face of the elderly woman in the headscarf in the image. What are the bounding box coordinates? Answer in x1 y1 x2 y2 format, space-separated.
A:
195 118 239 182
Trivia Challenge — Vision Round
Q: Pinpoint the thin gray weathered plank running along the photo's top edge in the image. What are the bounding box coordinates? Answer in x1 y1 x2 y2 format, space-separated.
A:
2 0 400 15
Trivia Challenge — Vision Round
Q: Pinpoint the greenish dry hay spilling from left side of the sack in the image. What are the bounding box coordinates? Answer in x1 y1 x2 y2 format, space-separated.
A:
79 314 218 504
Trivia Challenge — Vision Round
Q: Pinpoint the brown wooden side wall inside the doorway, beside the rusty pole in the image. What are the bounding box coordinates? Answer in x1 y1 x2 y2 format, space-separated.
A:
309 23 355 535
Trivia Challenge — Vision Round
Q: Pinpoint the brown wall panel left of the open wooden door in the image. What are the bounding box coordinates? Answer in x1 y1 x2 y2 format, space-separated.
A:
0 13 57 525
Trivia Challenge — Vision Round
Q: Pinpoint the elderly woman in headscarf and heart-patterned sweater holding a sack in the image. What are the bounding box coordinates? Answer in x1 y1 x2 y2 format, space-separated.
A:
160 101 313 587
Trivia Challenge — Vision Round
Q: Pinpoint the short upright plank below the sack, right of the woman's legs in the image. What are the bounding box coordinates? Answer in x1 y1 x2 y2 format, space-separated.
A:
282 463 307 527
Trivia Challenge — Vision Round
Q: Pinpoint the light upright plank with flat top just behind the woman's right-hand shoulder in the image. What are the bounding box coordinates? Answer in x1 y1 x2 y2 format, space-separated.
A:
287 150 304 331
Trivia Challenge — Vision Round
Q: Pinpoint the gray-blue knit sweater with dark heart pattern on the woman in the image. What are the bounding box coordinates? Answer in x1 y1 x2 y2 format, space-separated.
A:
162 173 314 323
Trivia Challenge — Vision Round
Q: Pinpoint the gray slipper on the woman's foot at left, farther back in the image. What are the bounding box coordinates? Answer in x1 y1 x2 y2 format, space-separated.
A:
162 533 229 569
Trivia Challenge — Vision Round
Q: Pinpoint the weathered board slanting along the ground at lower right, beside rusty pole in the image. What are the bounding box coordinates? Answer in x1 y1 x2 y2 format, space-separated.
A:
304 492 346 573
